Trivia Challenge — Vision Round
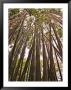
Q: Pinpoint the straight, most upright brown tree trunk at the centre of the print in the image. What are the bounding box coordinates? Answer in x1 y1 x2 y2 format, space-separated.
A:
35 25 41 81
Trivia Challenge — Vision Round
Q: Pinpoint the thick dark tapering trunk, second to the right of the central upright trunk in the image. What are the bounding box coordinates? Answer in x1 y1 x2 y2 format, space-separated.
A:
49 23 57 81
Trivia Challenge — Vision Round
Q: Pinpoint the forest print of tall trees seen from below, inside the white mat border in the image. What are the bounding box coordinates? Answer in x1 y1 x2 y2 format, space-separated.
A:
8 8 63 81
